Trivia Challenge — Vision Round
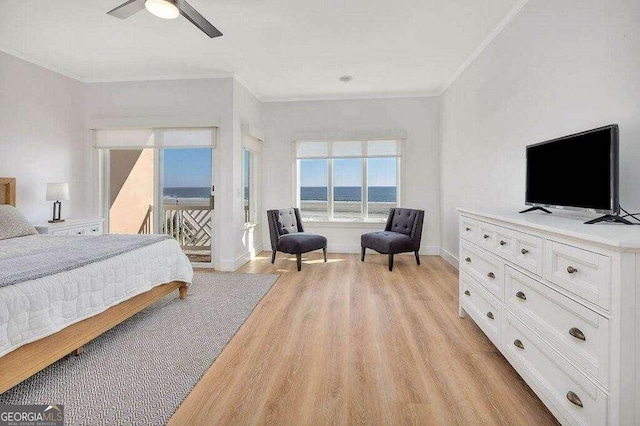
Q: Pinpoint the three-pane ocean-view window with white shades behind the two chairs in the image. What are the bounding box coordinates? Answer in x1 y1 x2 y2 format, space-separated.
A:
295 140 402 222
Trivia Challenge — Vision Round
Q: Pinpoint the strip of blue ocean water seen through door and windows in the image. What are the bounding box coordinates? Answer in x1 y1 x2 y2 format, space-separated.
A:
164 186 396 203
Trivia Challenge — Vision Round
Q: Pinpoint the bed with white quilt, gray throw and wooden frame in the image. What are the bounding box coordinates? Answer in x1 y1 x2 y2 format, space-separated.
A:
0 178 193 393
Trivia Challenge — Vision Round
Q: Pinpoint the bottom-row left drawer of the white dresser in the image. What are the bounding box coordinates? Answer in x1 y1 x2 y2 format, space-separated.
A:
460 273 503 346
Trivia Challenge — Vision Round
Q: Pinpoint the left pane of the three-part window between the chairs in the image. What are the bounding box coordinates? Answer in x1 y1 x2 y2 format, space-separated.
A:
298 159 329 220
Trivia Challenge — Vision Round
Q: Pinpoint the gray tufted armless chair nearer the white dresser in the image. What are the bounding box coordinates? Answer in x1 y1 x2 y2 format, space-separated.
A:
360 208 424 271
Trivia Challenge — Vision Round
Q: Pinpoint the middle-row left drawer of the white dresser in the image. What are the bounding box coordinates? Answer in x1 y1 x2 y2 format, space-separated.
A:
460 241 504 300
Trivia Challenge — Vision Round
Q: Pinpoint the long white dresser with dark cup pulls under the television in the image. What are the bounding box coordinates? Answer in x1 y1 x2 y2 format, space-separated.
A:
459 209 640 425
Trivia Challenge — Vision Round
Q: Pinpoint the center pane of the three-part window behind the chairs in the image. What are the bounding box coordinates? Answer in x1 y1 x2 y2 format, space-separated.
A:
333 158 362 220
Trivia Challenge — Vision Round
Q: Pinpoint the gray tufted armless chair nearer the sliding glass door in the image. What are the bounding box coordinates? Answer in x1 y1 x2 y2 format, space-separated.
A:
267 208 327 271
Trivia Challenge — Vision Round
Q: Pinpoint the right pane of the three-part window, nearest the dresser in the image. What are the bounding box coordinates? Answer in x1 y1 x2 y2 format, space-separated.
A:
367 158 398 219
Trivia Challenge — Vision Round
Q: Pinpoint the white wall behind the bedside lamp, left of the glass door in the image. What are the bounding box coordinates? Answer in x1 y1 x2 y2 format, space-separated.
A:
0 52 87 222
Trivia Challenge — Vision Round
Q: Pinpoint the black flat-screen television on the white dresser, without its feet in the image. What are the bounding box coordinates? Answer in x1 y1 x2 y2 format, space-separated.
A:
526 124 619 214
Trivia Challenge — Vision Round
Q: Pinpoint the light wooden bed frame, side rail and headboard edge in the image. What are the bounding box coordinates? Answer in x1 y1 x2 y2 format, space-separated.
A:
0 178 187 394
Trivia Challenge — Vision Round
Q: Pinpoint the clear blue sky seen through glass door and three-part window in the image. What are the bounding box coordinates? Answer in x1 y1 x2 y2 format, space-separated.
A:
164 149 396 188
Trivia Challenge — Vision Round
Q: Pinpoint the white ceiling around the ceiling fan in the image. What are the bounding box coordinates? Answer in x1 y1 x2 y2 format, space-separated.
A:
0 0 526 101
